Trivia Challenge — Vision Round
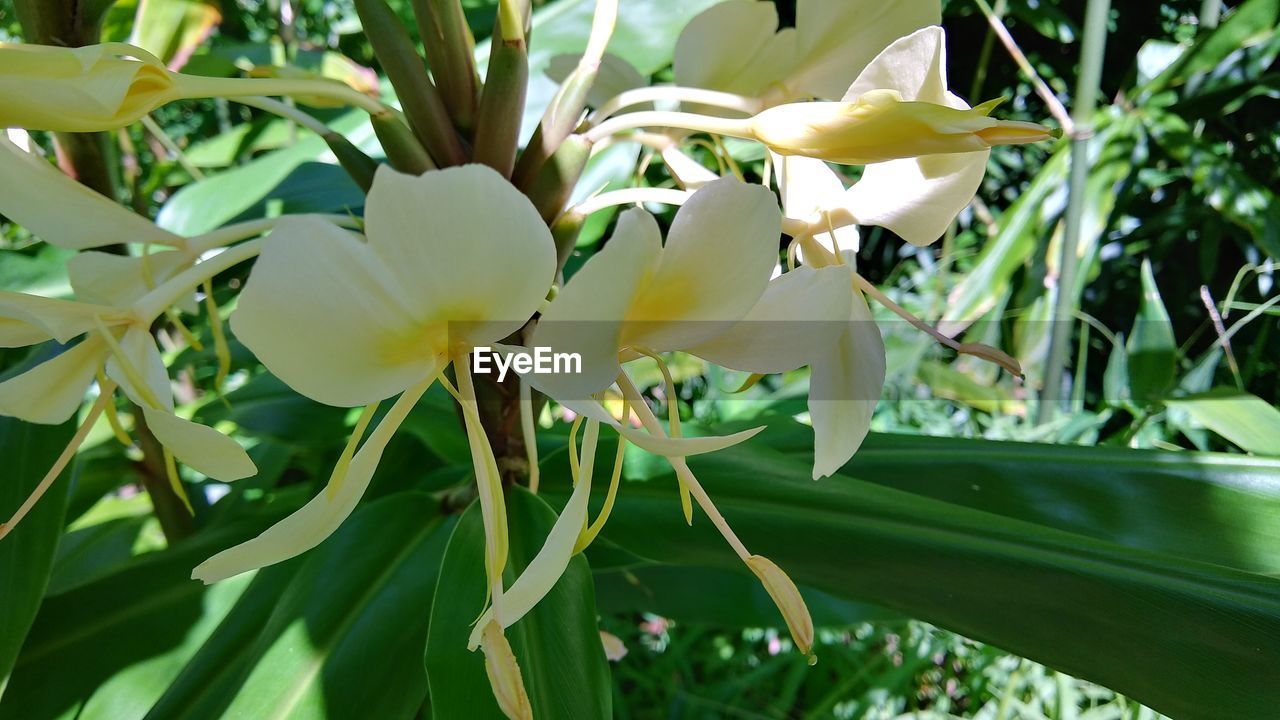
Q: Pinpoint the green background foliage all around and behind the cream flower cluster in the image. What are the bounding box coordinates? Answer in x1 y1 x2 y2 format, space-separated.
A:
0 0 1280 720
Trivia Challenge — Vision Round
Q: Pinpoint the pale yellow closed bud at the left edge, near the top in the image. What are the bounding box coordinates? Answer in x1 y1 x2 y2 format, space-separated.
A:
0 42 178 132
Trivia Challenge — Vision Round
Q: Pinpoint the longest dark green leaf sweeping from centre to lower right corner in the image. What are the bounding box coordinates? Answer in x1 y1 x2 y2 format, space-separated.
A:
543 443 1280 720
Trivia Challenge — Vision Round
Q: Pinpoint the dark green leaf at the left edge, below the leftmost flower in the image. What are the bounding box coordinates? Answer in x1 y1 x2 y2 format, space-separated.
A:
0 418 76 696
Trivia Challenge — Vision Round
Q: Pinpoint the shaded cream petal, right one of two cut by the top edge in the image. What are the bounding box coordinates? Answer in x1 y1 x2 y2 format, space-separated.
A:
787 0 942 100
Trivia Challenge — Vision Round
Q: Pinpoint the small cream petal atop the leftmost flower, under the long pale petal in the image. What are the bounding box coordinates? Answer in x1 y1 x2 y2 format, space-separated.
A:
67 250 191 306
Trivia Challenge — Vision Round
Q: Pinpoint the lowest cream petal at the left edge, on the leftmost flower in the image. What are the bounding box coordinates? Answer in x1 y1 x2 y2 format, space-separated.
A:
0 336 106 425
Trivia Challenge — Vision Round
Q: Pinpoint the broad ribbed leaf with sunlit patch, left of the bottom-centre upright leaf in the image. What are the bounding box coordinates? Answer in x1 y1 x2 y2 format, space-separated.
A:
202 493 451 717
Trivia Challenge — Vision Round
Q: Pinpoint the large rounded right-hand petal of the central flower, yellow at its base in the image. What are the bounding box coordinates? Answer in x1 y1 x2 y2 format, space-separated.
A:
365 165 556 345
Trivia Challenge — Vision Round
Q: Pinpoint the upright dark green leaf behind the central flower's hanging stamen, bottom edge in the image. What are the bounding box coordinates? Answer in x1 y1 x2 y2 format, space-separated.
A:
426 487 613 720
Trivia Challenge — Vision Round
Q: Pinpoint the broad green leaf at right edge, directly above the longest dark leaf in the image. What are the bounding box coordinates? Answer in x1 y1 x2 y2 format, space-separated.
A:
760 420 1280 575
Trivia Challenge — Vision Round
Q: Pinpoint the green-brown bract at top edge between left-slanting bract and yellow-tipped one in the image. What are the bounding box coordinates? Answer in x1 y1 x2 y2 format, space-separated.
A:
413 0 480 135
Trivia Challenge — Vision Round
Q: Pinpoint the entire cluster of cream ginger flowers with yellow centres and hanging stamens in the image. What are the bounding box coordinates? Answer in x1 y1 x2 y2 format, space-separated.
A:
0 0 1051 717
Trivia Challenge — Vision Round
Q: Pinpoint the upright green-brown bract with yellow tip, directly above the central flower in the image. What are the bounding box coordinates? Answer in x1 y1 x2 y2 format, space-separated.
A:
475 15 529 178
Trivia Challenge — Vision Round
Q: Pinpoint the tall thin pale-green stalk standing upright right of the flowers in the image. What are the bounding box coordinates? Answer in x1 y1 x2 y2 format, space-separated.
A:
1037 0 1111 423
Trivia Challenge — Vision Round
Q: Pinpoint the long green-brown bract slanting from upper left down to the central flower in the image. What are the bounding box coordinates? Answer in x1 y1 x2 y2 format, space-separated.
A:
356 0 467 167
